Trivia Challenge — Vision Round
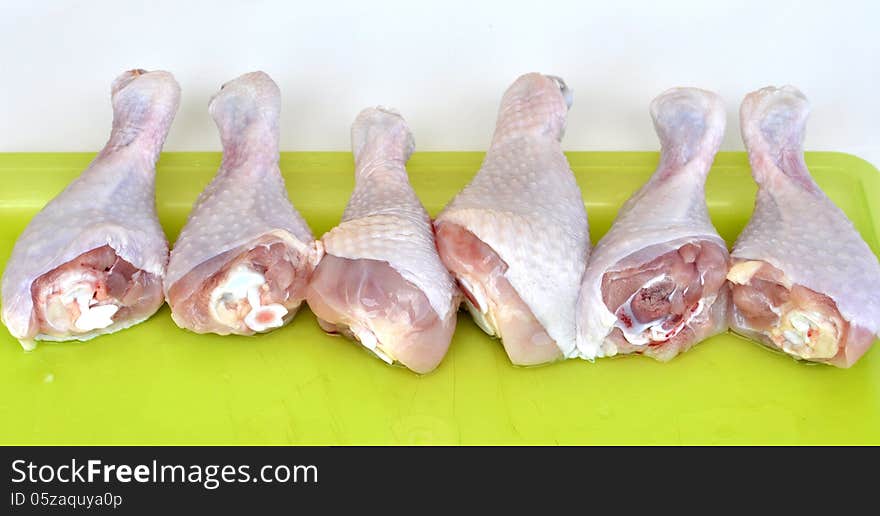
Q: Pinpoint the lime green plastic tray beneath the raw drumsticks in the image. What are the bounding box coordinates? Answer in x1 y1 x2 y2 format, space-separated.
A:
0 152 880 444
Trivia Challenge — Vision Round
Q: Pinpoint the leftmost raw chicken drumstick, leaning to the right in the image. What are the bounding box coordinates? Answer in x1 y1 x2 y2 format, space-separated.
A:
3 70 180 349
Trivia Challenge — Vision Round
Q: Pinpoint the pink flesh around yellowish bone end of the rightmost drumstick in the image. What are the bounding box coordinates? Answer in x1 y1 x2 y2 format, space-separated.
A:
731 263 874 367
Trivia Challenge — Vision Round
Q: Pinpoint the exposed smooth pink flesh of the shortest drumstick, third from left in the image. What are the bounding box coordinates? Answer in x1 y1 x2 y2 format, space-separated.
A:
306 254 456 374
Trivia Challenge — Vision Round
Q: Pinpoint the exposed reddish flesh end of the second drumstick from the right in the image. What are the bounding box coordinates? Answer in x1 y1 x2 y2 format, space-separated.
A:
602 241 727 360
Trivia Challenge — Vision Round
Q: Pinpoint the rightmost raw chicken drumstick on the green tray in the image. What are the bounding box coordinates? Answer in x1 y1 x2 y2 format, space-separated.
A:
727 86 880 367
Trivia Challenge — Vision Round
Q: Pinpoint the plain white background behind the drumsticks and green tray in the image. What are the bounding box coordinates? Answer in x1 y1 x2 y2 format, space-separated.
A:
0 0 880 164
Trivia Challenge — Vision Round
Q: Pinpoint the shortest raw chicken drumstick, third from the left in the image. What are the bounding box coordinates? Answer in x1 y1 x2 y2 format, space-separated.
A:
307 107 459 373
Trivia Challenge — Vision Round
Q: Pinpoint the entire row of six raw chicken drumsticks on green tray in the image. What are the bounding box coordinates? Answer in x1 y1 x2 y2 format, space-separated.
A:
2 70 880 373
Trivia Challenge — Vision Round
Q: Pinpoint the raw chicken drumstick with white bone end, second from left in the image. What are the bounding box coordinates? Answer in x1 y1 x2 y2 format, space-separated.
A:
165 72 320 335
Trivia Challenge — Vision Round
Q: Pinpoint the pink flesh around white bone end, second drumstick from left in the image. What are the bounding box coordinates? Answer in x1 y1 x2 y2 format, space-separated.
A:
168 237 311 335
